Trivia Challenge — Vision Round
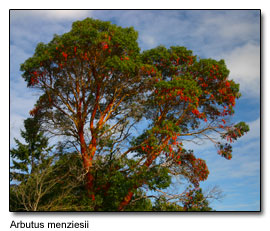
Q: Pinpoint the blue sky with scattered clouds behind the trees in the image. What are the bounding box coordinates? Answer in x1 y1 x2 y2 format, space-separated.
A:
10 10 260 211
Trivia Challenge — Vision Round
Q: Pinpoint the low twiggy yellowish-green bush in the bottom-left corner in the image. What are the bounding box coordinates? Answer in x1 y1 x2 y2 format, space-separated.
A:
10 153 87 211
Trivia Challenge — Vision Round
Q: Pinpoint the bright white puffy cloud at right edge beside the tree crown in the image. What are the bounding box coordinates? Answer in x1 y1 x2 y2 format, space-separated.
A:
221 43 260 97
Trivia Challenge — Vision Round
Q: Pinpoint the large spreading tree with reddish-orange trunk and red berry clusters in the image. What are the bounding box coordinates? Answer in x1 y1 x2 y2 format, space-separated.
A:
21 18 249 210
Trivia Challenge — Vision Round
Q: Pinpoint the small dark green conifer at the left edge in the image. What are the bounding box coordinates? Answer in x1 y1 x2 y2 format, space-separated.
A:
10 117 52 210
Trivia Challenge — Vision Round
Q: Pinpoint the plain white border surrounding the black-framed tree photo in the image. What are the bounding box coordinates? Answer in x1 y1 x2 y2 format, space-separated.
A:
0 0 270 231
